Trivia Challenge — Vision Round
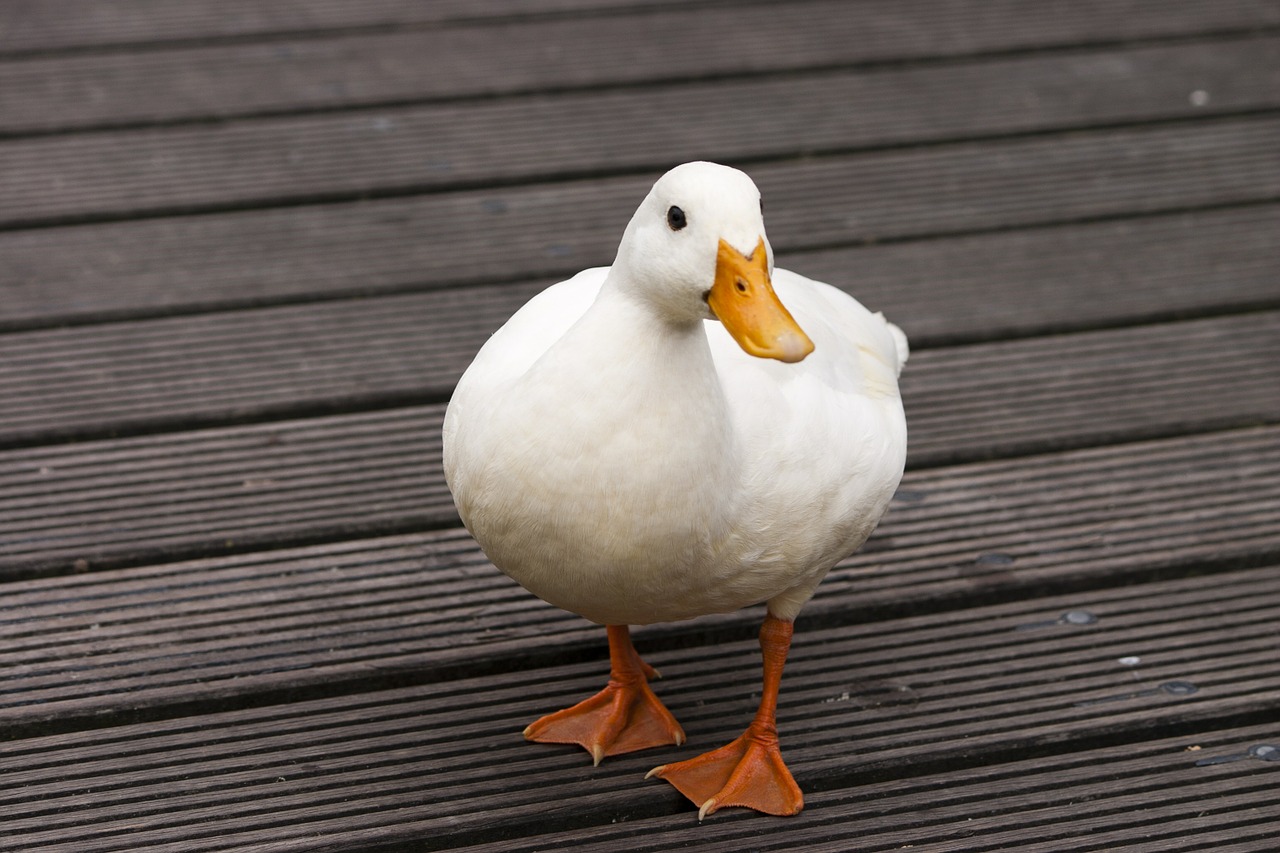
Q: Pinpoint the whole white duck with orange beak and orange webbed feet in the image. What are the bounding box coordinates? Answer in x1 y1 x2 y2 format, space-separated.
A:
444 163 906 818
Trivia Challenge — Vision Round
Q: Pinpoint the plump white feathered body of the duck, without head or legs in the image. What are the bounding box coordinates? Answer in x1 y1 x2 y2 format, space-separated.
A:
445 262 906 625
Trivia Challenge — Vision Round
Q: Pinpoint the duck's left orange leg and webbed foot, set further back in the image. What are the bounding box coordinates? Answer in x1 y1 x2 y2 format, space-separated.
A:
525 625 685 765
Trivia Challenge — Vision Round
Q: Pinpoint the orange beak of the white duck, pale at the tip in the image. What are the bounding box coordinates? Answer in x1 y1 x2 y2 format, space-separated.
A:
707 237 813 362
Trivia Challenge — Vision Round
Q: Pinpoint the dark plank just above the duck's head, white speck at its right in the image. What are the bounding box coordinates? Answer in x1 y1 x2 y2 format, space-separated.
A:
10 38 1280 223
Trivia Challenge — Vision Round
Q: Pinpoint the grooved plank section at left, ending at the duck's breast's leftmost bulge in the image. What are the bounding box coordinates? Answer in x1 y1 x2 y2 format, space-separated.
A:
0 407 453 569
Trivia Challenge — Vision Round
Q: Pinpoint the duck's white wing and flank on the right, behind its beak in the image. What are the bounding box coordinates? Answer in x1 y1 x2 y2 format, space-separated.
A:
707 263 908 617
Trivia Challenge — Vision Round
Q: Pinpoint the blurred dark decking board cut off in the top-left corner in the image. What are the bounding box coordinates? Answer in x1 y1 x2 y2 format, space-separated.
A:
0 0 680 53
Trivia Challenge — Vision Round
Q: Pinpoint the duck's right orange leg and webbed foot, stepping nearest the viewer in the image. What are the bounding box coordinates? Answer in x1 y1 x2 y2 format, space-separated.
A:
646 613 804 820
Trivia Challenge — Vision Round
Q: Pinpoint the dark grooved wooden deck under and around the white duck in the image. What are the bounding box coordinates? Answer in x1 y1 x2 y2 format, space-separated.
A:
0 0 1280 853
